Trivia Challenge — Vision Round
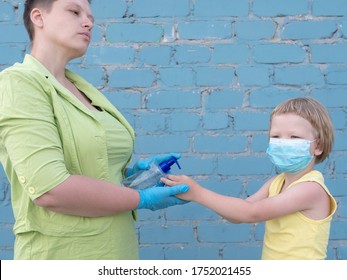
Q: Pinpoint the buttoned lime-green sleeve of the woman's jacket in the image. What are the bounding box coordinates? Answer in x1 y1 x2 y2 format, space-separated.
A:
0 68 69 200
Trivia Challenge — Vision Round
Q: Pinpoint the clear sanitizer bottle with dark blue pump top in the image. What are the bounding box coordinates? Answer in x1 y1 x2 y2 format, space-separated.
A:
122 157 181 190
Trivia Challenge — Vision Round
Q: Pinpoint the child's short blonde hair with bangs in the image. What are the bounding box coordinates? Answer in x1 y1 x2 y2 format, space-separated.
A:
270 98 334 163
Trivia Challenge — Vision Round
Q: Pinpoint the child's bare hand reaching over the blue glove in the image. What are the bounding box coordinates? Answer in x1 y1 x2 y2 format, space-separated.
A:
161 174 202 201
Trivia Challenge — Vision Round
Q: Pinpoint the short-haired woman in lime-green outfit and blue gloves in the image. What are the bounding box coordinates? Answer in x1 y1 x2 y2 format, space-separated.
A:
0 0 187 259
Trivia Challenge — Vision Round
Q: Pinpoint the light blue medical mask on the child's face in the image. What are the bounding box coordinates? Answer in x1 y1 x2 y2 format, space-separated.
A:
266 138 315 173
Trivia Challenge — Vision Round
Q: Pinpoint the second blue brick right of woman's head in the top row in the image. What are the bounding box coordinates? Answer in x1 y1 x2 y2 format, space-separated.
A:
129 0 190 18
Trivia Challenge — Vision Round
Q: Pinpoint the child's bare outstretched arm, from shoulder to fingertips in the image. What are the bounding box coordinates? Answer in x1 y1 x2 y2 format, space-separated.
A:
162 175 327 223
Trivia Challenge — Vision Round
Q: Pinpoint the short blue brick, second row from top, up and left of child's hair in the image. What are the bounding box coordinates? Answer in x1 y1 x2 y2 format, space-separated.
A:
236 20 277 41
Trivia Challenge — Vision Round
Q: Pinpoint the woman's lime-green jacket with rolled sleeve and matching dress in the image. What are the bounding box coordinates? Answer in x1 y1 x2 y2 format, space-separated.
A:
0 55 138 259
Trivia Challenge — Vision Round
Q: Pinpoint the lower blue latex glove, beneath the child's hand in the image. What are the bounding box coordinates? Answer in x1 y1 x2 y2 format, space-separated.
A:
137 184 189 211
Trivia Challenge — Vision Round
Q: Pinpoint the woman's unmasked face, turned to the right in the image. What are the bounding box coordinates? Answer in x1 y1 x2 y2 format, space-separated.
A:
34 0 94 59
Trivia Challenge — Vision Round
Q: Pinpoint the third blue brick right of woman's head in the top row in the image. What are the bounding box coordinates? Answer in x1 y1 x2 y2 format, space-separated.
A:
194 0 249 17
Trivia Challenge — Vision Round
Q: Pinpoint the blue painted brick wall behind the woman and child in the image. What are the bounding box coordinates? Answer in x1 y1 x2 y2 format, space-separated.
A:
0 0 347 259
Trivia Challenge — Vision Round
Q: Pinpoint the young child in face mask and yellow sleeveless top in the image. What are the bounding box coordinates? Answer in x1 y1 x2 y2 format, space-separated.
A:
162 98 336 259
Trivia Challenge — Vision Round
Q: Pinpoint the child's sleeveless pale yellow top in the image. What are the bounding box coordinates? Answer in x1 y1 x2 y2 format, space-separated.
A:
262 170 337 260
